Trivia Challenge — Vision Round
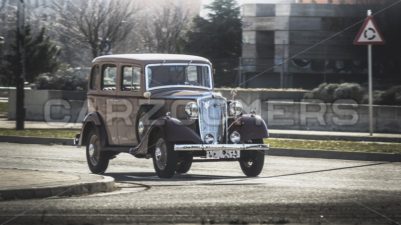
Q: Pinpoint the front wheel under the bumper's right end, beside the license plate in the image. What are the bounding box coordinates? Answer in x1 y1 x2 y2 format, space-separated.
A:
239 139 265 177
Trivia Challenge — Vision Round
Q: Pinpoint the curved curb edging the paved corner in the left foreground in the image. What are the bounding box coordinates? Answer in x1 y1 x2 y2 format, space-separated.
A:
0 176 116 201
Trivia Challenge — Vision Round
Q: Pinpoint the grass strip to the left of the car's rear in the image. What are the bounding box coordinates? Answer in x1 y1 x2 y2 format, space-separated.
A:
0 128 80 138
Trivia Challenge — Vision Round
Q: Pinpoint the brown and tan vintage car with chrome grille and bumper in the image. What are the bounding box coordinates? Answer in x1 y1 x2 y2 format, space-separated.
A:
75 54 268 178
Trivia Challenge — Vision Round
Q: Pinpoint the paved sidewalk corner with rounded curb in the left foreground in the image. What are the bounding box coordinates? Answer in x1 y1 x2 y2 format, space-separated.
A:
0 169 115 201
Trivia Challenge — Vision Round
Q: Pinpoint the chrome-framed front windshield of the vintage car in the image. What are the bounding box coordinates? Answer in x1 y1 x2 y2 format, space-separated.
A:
146 64 212 90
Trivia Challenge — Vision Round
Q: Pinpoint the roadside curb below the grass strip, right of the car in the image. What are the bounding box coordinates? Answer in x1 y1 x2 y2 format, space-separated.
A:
267 148 401 162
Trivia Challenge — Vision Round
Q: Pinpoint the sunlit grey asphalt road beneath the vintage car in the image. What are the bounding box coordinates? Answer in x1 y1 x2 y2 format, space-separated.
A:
0 143 401 225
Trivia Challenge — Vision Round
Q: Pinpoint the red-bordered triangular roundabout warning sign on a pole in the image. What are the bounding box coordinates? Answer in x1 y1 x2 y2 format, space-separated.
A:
354 16 384 45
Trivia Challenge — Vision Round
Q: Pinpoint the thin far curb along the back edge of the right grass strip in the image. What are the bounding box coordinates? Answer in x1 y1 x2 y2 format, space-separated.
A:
269 132 401 143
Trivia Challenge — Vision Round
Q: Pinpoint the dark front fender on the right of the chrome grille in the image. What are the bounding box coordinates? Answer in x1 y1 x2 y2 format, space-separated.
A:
229 114 269 142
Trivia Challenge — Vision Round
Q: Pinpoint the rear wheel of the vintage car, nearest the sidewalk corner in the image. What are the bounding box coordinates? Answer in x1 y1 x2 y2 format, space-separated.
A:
86 128 110 174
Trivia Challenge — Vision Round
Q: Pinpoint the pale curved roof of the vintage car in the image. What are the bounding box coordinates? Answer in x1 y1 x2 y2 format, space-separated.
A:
92 54 210 63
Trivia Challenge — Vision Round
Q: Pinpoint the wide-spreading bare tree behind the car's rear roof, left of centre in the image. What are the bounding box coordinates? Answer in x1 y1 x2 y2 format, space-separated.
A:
52 0 135 57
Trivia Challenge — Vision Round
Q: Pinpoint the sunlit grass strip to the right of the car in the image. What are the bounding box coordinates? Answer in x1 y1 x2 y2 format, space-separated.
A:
265 138 401 153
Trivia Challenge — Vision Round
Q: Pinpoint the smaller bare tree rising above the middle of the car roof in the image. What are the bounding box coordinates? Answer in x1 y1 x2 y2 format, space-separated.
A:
141 4 190 53
